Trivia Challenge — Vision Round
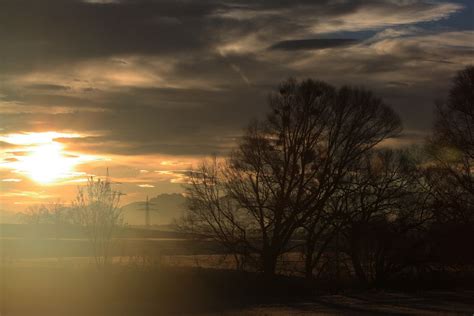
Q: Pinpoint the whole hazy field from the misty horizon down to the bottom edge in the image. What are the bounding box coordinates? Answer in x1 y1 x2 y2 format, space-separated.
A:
0 226 474 316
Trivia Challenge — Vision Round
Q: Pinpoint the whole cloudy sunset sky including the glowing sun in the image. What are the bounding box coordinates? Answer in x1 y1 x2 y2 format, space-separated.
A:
0 0 474 211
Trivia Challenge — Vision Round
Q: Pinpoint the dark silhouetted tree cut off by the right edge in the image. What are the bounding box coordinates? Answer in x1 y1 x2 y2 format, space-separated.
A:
424 66 474 266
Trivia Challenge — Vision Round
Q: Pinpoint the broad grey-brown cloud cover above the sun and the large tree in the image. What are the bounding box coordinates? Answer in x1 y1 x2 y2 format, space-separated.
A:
0 0 472 155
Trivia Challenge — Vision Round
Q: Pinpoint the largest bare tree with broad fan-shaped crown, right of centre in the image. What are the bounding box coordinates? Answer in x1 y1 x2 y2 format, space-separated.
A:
181 79 400 276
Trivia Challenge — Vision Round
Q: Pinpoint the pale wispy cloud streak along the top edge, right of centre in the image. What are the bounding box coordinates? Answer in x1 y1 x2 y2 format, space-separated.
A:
215 0 464 33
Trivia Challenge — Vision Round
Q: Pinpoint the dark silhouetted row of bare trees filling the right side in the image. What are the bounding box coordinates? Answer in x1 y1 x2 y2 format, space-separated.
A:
179 66 474 287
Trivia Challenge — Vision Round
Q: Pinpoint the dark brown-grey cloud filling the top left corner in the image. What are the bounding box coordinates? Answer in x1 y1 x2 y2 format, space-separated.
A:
0 0 220 70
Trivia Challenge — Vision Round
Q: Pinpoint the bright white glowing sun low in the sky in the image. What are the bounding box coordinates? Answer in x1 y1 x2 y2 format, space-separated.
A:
19 142 75 184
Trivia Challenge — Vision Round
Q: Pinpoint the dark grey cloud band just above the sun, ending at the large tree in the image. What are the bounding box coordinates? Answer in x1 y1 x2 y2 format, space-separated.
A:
2 85 266 155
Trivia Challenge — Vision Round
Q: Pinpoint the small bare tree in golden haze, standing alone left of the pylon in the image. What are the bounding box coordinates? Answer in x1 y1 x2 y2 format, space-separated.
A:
73 177 123 268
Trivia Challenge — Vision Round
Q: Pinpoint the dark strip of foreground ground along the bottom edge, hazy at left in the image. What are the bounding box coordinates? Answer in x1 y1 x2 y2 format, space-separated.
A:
0 266 474 316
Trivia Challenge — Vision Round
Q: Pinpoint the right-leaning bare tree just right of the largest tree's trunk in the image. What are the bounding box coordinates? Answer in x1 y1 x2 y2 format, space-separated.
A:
286 87 401 278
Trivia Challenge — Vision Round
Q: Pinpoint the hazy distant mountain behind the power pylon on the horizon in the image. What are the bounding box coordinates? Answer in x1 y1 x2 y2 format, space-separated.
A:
122 193 186 226
